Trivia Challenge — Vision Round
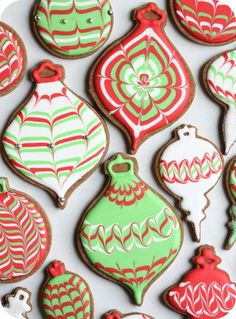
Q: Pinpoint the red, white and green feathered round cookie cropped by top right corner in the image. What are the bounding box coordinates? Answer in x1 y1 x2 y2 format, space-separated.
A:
170 0 236 45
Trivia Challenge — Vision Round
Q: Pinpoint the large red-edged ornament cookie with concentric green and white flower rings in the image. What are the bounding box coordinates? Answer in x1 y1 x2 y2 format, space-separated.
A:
90 3 195 153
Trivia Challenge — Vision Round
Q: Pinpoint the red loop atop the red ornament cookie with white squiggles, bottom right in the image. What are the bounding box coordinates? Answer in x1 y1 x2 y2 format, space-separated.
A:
194 247 221 269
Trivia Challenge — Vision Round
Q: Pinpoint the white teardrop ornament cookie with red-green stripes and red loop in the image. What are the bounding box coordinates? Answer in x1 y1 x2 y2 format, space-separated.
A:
3 61 109 208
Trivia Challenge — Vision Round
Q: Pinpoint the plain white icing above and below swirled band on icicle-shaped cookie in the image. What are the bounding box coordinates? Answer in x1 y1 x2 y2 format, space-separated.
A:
160 126 223 240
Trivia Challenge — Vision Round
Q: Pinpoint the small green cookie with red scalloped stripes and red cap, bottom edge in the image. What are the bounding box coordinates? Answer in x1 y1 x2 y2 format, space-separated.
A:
42 261 93 319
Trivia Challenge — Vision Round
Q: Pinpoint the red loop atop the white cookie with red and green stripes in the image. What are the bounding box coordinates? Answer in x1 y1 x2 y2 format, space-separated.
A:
32 60 64 83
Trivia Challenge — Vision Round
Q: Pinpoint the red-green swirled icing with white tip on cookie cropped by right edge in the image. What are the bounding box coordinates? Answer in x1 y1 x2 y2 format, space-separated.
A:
207 50 236 154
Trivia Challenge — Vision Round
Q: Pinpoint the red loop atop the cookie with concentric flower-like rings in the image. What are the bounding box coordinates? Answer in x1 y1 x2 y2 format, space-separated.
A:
135 2 166 27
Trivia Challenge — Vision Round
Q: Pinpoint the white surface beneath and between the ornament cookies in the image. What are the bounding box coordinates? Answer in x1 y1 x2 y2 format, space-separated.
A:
0 0 236 319
